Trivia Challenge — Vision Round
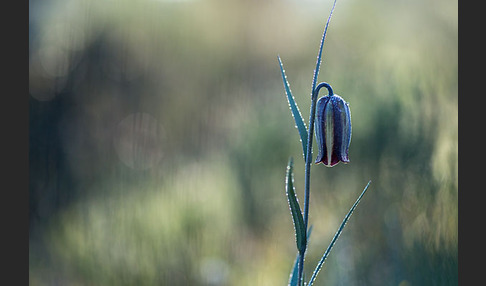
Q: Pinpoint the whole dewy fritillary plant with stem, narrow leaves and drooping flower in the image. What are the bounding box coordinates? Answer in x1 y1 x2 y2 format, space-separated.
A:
278 0 371 286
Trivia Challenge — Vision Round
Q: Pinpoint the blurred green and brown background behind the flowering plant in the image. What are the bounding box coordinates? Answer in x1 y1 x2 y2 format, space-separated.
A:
29 0 458 286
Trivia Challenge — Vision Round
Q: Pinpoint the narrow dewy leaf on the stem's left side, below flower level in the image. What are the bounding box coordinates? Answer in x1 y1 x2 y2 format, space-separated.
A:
285 157 307 255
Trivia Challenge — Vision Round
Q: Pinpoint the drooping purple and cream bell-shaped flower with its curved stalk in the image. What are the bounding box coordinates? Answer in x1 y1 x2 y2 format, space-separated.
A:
315 83 351 167
